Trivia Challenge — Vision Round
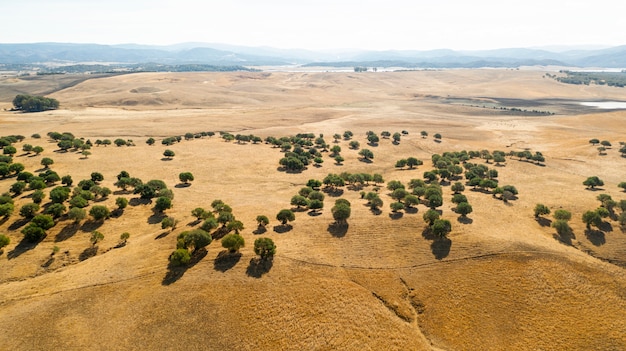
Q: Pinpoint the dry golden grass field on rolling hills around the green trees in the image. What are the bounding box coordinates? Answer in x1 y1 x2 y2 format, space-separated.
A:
0 69 626 350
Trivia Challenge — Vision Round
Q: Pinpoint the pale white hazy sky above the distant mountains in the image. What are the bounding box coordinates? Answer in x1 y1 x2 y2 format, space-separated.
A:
0 0 626 50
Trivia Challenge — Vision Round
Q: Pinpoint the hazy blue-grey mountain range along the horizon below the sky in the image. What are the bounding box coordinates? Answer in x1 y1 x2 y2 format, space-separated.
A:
0 43 626 68
